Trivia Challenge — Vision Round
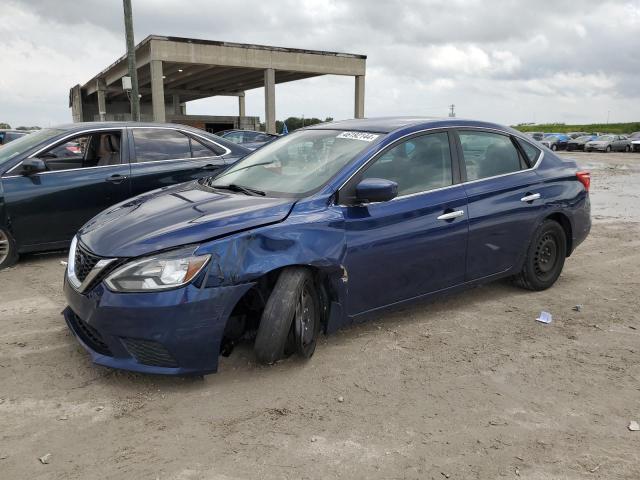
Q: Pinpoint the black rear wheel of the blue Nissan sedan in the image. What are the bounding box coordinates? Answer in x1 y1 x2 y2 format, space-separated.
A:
513 220 567 291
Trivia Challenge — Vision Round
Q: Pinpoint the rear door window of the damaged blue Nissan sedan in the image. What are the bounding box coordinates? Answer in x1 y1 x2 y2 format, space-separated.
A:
458 130 523 180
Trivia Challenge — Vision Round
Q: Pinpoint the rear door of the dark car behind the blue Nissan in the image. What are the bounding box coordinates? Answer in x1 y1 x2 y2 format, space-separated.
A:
128 127 227 195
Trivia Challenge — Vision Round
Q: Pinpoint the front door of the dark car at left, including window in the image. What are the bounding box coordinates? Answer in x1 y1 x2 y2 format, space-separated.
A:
2 130 131 246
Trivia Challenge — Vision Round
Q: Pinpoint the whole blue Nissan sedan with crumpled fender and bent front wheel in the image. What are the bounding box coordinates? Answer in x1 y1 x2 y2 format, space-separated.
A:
64 118 591 374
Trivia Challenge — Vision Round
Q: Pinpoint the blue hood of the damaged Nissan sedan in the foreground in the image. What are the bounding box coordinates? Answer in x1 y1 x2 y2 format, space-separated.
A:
78 182 295 257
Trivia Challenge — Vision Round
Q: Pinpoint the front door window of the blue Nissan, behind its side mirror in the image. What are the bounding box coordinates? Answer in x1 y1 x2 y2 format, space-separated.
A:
362 132 453 196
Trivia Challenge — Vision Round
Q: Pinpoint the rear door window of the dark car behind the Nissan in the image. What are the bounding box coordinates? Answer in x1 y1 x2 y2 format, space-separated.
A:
132 128 191 162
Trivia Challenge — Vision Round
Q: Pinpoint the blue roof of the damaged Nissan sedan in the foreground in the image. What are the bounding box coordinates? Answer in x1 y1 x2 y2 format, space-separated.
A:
305 117 520 133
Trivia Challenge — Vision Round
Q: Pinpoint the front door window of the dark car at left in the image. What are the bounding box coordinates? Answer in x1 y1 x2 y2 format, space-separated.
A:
38 131 121 171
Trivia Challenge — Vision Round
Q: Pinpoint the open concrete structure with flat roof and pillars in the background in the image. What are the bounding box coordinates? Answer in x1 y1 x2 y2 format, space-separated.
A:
69 35 367 133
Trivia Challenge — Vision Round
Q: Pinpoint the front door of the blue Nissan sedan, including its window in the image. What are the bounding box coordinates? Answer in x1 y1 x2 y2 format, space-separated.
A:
340 131 467 315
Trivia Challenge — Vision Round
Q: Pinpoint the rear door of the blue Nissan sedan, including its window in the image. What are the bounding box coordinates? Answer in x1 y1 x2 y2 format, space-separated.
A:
457 129 544 281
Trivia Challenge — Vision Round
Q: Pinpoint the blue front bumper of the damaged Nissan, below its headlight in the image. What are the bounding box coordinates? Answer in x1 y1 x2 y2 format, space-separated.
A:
63 276 253 375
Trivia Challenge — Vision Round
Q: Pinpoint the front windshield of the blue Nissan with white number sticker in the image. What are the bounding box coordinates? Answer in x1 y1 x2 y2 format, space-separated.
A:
206 130 382 197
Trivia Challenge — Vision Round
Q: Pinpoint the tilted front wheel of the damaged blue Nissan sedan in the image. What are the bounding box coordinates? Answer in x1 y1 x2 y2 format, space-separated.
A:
254 267 321 364
